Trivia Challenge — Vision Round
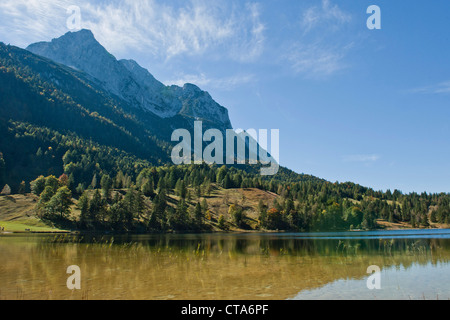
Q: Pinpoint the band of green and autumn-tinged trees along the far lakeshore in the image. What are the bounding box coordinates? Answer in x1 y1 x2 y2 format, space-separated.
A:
30 164 450 232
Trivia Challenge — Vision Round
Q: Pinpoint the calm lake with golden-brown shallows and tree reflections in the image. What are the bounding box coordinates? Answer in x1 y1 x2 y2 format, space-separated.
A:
0 230 450 300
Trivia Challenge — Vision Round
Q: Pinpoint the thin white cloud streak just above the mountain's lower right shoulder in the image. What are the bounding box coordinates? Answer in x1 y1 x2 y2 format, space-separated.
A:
164 73 256 91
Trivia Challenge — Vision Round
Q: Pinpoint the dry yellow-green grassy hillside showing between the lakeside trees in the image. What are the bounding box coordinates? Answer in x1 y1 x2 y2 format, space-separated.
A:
0 188 450 233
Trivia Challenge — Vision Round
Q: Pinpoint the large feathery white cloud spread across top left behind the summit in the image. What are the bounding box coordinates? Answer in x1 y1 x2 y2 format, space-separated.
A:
0 0 265 61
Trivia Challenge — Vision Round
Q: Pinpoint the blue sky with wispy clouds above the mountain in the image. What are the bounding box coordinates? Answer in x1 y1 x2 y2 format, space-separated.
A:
0 0 450 192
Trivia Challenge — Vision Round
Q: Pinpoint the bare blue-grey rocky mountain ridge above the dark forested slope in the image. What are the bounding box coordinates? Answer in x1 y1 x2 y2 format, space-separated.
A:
27 30 232 130
